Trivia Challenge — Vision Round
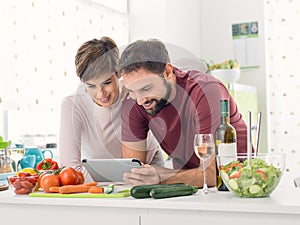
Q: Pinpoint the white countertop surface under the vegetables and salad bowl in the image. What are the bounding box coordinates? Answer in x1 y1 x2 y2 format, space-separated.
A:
0 183 300 216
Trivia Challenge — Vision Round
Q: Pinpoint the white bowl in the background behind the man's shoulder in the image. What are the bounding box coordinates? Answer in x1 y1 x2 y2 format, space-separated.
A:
210 69 241 84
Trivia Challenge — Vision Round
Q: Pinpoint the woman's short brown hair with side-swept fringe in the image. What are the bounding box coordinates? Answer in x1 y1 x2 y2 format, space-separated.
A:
75 37 119 82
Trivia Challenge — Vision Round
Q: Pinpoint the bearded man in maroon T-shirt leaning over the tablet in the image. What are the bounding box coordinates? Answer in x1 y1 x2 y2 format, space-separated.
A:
119 39 247 187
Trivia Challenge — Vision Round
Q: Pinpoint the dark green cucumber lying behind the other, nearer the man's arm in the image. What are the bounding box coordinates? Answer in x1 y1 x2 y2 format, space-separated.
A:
130 183 187 198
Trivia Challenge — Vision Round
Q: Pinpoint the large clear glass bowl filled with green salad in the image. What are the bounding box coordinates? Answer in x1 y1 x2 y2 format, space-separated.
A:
217 153 285 198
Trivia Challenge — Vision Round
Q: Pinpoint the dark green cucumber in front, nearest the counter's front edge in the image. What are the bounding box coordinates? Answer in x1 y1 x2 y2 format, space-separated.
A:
150 185 198 199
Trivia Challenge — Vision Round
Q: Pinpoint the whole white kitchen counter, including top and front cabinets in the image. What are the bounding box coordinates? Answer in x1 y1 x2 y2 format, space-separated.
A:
0 183 300 225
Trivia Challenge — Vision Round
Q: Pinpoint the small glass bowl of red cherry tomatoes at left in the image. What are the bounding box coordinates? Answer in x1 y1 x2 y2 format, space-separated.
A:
7 173 39 195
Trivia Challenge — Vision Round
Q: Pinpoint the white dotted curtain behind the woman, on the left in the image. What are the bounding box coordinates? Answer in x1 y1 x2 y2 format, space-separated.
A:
0 0 129 145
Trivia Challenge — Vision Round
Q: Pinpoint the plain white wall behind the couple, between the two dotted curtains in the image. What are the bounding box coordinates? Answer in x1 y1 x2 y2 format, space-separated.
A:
129 0 267 149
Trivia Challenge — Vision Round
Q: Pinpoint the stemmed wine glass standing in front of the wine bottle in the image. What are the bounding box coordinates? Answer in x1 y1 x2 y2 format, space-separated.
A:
194 134 215 194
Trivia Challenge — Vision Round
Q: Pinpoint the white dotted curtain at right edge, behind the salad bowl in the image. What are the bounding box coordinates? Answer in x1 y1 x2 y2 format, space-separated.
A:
265 0 300 184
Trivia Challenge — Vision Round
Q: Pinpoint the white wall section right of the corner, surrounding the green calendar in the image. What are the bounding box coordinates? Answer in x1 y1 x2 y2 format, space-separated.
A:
200 0 268 151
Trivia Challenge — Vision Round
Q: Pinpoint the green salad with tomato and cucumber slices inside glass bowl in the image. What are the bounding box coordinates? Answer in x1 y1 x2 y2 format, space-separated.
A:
220 158 282 198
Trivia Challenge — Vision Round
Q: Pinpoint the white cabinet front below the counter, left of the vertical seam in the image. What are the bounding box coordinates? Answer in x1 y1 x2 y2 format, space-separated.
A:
0 202 141 225
